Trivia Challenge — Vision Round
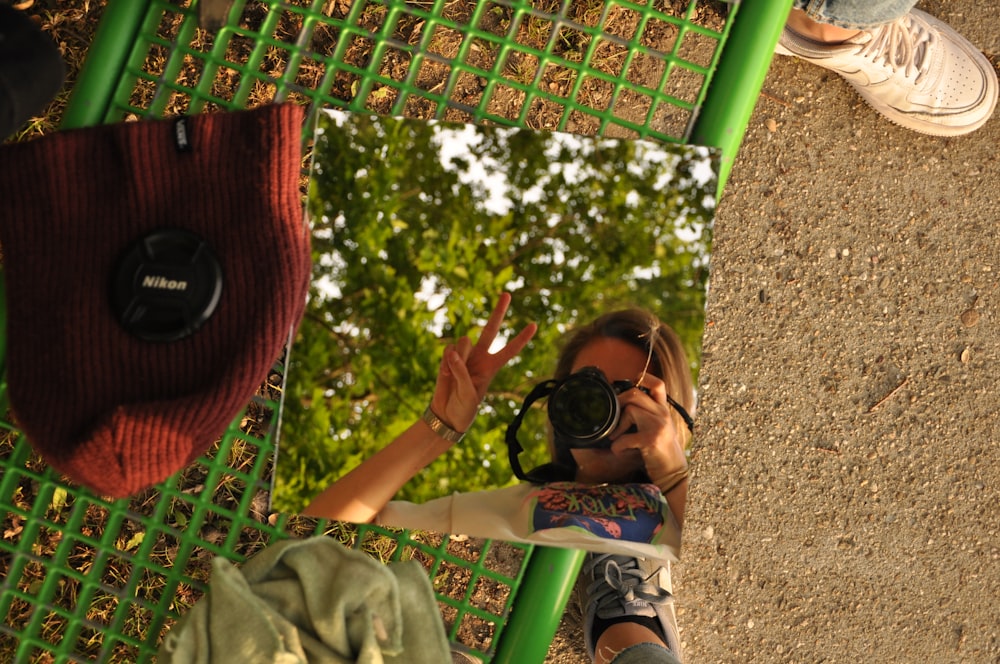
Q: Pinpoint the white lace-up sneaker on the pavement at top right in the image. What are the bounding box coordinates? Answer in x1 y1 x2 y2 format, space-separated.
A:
775 9 998 136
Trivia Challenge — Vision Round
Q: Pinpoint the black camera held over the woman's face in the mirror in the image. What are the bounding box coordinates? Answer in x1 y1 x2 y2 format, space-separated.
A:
548 367 650 449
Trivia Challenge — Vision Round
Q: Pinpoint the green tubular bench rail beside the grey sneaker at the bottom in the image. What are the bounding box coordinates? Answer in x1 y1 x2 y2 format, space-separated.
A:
491 546 586 664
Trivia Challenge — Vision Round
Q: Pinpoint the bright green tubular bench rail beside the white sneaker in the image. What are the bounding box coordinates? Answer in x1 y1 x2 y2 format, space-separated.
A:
688 0 792 197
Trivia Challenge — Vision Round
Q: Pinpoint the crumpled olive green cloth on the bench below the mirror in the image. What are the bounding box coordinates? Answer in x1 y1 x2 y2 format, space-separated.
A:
158 537 451 664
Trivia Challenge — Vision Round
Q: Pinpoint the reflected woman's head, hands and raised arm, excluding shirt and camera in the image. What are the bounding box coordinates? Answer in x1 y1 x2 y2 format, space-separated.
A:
304 293 695 528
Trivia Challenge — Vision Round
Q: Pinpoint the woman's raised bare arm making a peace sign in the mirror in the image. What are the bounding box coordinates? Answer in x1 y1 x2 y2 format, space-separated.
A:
303 293 537 522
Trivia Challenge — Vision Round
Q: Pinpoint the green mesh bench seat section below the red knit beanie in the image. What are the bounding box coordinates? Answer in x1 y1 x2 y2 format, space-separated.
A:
0 360 531 662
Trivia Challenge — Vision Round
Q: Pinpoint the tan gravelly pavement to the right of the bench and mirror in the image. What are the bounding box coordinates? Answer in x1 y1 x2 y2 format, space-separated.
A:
674 0 1000 662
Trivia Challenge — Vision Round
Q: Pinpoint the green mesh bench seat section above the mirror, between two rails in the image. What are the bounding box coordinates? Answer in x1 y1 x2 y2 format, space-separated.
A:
70 0 729 142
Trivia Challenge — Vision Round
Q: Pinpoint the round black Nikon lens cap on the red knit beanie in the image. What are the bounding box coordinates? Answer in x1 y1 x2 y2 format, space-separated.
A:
111 228 222 342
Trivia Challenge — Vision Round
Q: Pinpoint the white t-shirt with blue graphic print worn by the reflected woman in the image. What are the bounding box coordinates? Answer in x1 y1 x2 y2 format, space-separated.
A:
376 482 681 560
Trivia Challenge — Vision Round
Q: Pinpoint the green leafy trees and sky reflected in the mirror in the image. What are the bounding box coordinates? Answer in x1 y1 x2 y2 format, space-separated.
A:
272 111 718 546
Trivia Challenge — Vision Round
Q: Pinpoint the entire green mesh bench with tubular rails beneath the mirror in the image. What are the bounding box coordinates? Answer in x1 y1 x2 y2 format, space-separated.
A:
0 0 791 662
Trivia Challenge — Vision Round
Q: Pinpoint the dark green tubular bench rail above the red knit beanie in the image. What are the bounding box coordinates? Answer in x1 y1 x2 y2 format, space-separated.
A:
60 0 147 129
